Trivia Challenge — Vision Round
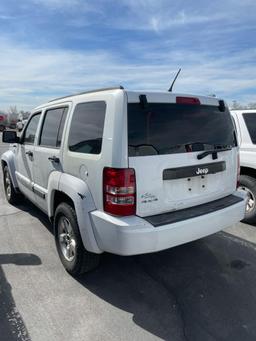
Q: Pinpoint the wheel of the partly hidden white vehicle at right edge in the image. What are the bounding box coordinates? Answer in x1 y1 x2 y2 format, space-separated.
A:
240 175 256 224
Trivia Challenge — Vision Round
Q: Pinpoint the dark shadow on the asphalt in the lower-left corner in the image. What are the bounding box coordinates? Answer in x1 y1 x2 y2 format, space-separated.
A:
0 253 41 341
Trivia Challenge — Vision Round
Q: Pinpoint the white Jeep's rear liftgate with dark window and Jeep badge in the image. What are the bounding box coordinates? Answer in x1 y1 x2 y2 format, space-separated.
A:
127 94 237 217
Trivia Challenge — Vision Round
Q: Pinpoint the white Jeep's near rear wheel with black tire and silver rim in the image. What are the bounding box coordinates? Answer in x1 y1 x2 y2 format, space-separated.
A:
54 203 100 276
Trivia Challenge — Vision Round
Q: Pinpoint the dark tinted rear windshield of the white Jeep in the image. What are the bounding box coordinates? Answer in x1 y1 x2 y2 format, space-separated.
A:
128 103 236 156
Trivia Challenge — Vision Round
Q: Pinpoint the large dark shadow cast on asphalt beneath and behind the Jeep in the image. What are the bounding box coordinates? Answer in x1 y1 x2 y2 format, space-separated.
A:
8 202 256 341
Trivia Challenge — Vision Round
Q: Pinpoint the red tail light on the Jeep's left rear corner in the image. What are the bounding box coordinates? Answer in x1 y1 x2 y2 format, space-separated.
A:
103 167 136 216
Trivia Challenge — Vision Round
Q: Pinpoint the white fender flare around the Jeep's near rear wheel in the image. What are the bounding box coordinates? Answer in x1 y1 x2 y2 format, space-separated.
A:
49 173 102 253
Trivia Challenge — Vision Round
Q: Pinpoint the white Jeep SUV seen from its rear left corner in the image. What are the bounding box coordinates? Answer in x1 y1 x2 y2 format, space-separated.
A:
2 87 246 275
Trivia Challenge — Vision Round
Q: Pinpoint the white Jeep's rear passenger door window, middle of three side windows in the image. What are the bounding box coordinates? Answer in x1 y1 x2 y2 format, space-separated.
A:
39 108 68 147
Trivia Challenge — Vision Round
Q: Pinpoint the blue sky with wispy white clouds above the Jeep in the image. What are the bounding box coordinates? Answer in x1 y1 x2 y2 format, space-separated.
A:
0 0 256 109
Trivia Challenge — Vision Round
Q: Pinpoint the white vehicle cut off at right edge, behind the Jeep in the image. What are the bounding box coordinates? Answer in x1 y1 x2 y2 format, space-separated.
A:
231 109 256 224
